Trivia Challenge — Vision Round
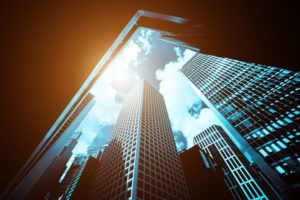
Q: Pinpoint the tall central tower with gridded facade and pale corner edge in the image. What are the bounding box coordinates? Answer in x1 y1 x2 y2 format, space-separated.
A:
90 81 189 199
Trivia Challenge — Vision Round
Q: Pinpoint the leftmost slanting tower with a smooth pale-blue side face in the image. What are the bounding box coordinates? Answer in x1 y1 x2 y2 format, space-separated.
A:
0 93 96 199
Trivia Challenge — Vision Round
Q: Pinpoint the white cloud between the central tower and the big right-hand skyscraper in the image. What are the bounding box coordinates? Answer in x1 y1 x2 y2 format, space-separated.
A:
156 47 218 148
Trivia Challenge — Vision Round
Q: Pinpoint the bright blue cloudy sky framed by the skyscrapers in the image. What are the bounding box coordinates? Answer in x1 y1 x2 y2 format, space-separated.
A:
73 28 219 157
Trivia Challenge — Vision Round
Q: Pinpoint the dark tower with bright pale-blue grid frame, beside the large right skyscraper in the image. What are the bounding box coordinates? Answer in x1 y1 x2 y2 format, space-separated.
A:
194 125 281 200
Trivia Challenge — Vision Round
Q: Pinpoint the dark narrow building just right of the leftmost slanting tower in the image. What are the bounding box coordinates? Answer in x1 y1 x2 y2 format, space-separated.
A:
27 133 81 199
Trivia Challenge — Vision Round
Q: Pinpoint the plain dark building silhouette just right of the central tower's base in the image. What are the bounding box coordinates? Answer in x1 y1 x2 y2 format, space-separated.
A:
179 145 234 200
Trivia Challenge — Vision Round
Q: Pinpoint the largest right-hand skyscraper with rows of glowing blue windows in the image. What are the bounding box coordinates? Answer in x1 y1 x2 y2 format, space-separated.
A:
181 53 300 197
